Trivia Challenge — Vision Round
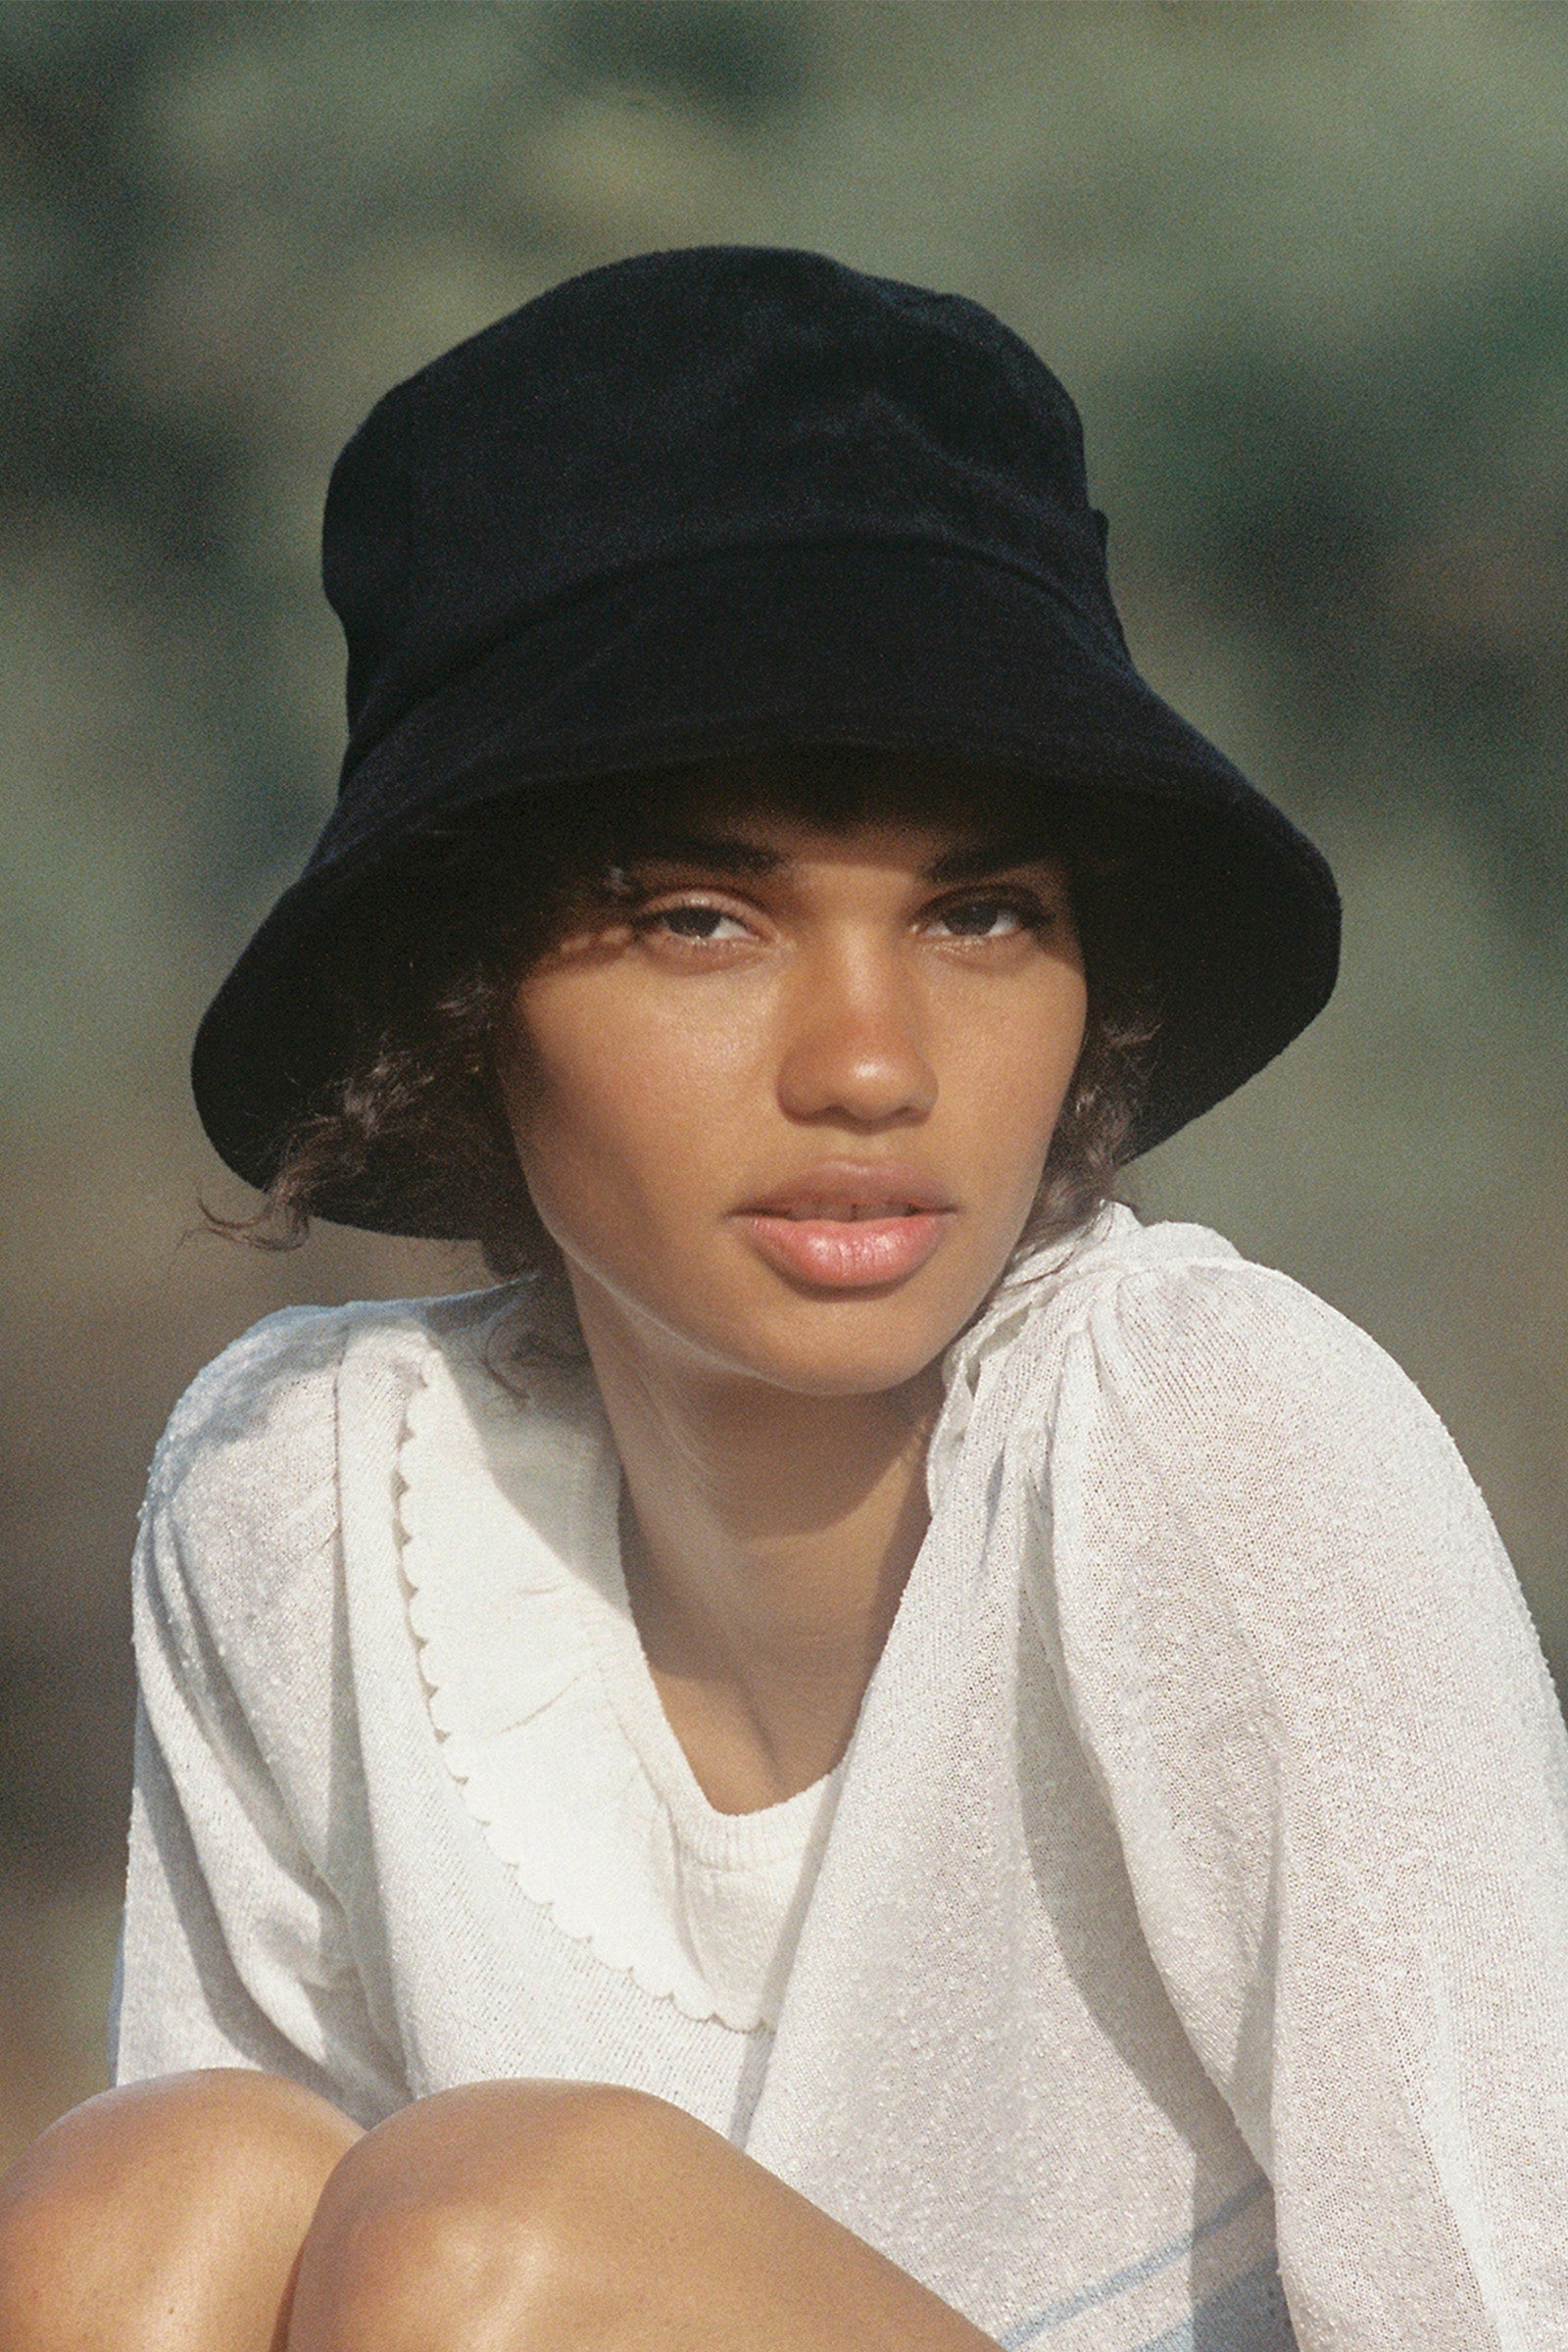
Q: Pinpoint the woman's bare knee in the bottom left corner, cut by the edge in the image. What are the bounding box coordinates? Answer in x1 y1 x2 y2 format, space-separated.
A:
0 2070 360 2352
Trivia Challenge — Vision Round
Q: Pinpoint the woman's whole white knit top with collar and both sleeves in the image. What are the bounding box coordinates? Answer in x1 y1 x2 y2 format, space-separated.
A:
118 1211 1568 2352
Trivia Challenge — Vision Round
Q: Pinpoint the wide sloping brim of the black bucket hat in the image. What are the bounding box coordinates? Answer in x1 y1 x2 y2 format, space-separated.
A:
193 541 1340 1240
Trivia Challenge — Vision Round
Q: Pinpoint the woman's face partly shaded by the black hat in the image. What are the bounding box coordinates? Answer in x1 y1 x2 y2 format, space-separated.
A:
503 809 1086 1395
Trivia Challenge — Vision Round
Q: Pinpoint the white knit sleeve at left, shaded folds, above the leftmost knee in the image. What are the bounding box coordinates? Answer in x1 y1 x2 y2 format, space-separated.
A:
111 1310 407 2122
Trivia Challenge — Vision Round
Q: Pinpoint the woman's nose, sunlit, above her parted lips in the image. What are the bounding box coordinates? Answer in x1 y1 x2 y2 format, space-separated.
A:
778 955 936 1127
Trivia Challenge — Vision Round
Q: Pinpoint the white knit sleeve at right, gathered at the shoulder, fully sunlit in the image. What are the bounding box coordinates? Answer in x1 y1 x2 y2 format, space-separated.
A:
1034 1260 1568 2352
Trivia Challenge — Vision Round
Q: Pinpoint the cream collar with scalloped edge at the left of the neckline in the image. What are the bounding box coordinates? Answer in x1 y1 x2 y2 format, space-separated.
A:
397 1307 842 2033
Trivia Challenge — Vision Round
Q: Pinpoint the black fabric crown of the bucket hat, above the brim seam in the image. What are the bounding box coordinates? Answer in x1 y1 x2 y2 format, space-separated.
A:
324 247 1126 778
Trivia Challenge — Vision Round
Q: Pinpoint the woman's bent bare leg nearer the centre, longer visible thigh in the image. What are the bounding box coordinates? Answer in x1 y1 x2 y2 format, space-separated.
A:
287 2083 995 2352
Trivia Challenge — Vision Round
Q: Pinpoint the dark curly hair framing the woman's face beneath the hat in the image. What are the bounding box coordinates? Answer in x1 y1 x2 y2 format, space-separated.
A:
205 751 1154 1280
